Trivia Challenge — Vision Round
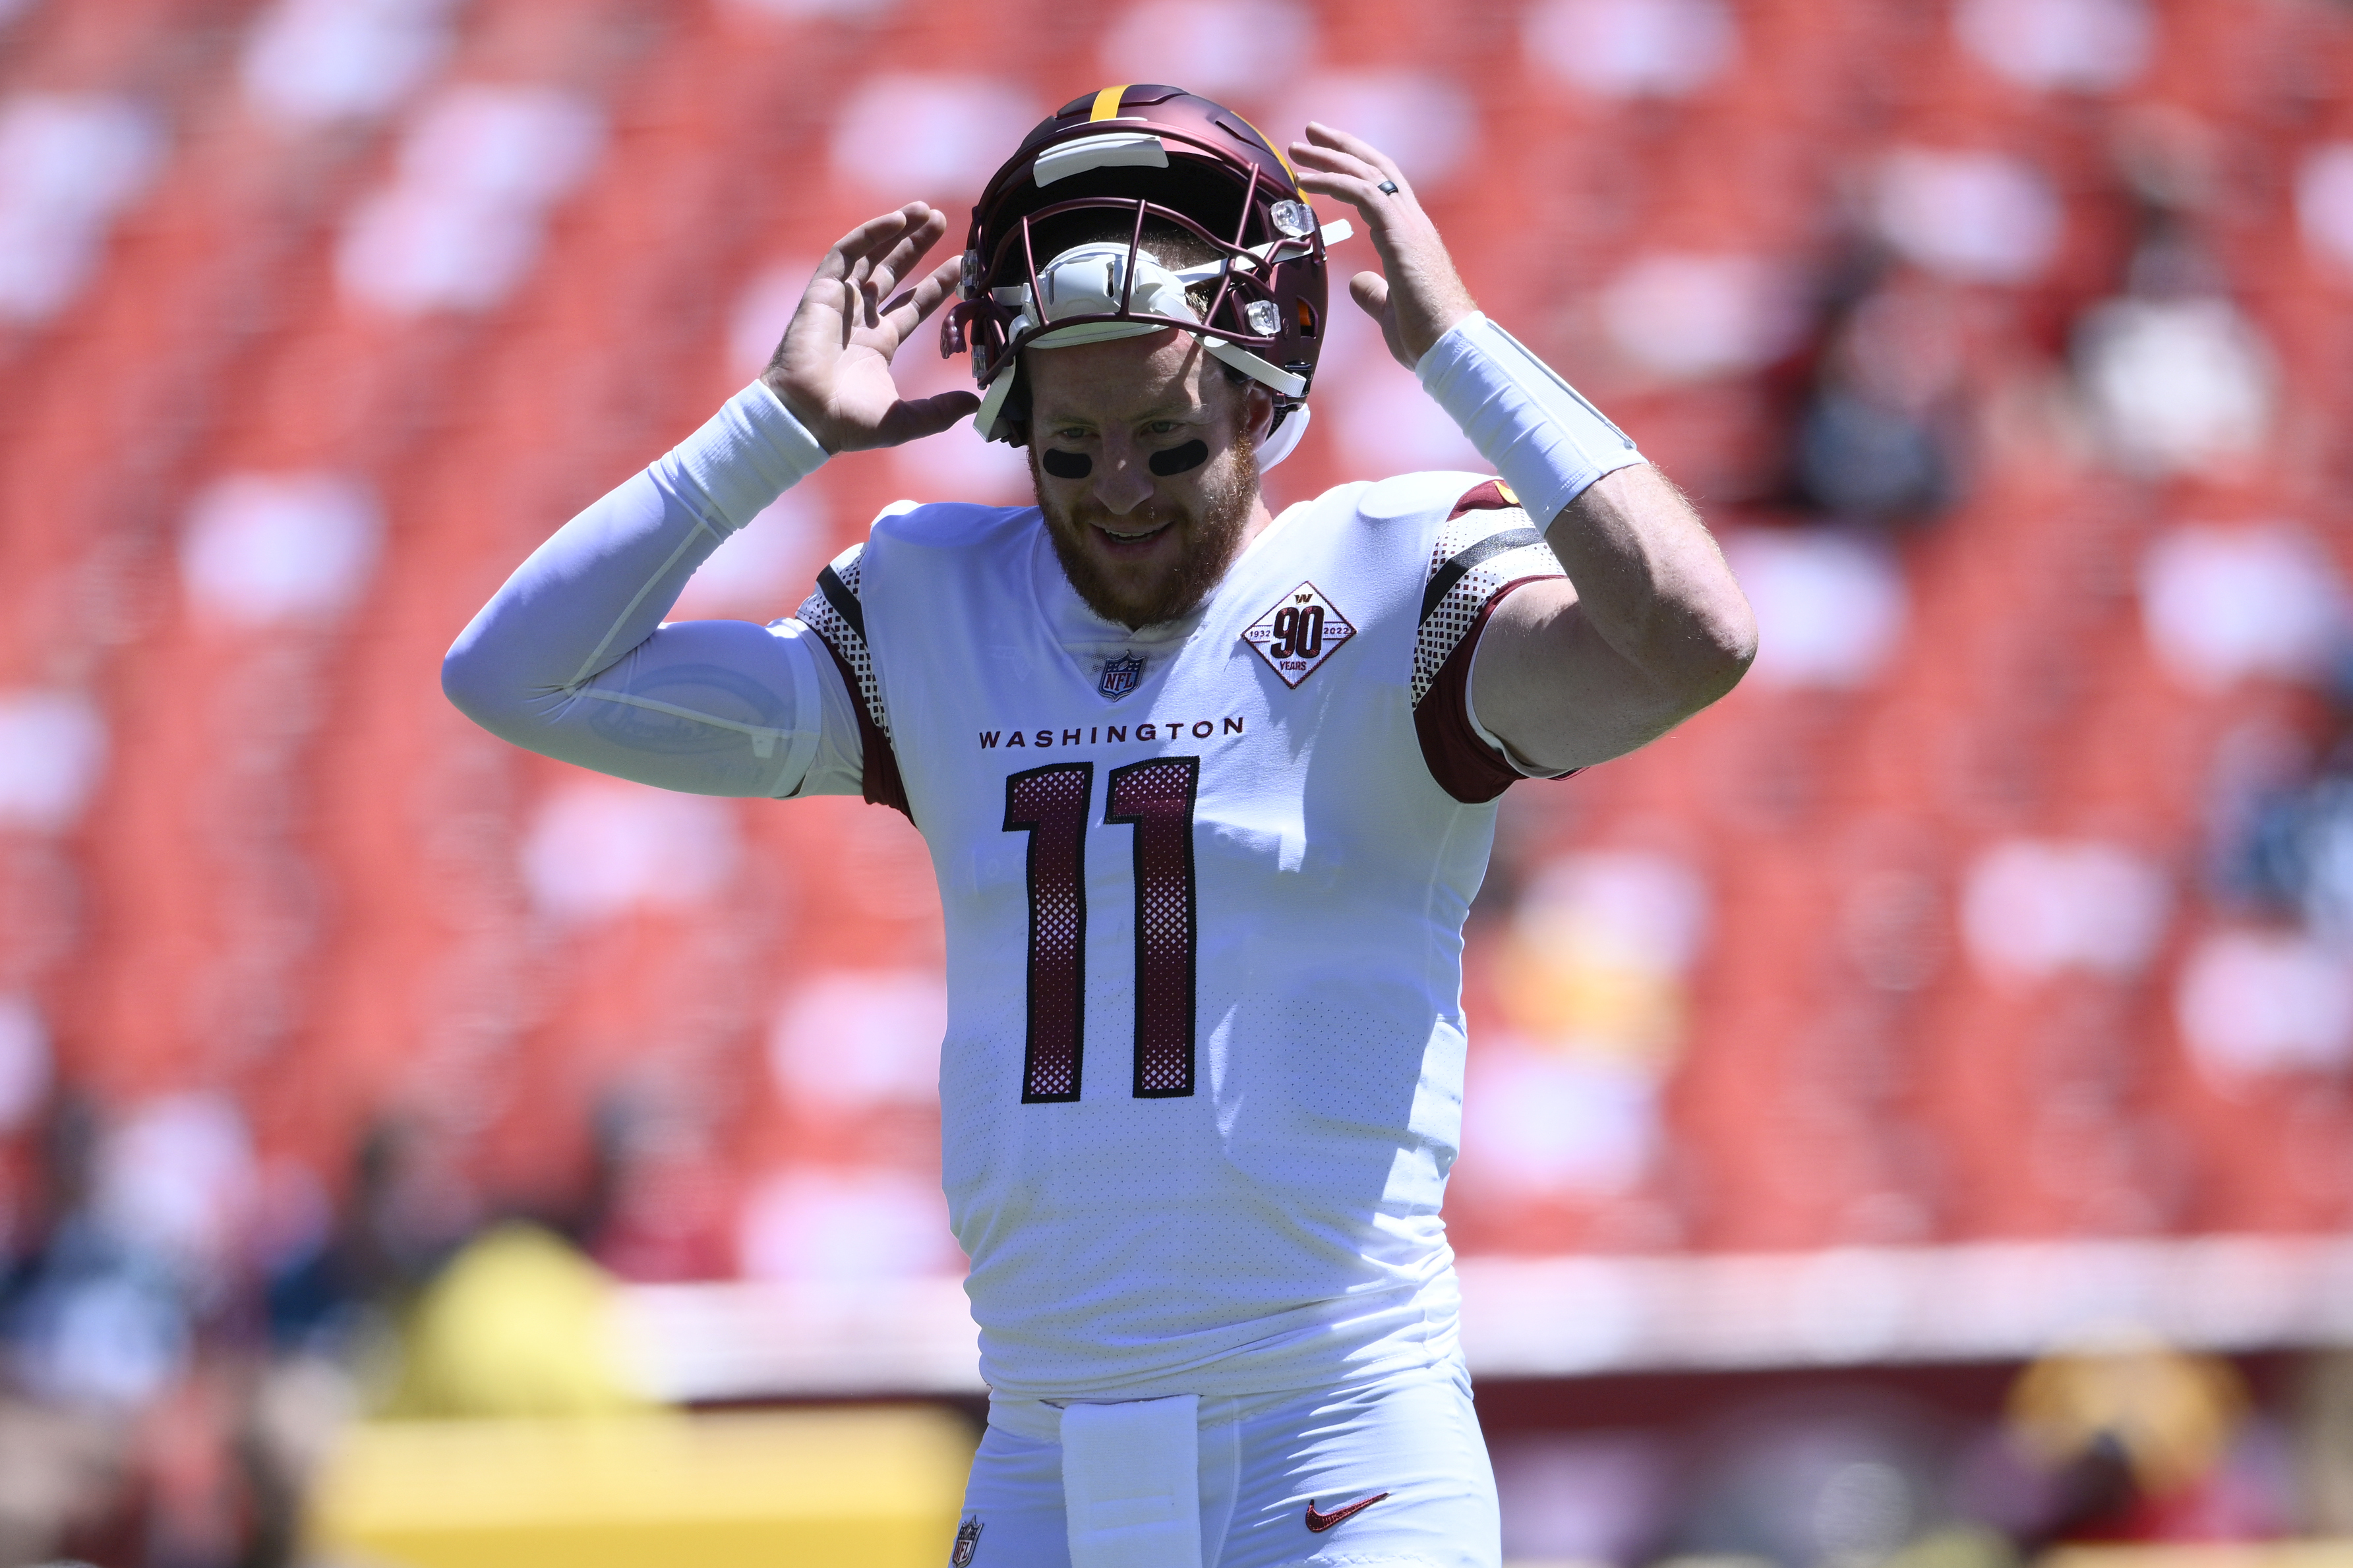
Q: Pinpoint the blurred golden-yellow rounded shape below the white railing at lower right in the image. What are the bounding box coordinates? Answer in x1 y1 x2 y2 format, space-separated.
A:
2010 1331 2247 1495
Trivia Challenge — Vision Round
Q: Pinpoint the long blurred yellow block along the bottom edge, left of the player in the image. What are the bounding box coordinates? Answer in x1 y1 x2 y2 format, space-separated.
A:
311 1406 974 1568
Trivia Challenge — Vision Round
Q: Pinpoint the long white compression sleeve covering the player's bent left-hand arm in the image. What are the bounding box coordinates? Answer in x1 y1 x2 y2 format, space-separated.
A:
442 383 856 795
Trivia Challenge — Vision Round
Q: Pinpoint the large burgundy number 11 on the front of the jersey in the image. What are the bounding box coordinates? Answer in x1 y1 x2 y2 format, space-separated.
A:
1005 757 1200 1103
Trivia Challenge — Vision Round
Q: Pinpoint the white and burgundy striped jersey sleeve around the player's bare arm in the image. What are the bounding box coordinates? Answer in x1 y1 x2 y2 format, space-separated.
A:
1412 480 1564 801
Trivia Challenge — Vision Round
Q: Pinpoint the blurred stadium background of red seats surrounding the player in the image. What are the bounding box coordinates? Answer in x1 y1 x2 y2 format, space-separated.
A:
0 0 2353 1568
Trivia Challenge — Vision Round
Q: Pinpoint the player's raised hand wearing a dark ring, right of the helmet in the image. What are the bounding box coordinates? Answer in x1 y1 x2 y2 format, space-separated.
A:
1292 120 1477 369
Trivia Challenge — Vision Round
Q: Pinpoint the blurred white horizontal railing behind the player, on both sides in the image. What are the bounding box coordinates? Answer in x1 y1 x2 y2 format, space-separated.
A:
624 1236 2353 1401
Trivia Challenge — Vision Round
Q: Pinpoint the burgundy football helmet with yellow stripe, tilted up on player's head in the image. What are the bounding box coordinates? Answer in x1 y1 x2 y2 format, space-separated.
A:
939 84 1348 451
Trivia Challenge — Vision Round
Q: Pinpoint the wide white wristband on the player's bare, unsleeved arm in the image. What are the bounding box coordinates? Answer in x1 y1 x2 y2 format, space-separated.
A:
1414 310 1642 529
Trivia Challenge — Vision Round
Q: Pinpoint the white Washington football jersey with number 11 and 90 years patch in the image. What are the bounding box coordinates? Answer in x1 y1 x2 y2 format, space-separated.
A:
800 475 1560 1399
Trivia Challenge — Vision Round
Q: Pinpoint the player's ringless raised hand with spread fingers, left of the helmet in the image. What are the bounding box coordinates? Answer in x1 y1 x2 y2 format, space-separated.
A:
760 202 981 451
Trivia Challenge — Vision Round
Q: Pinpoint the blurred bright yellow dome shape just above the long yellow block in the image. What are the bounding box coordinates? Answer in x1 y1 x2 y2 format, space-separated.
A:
384 1223 647 1418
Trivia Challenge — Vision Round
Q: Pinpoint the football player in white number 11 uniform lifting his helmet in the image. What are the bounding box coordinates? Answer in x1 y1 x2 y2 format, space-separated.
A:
442 84 1755 1568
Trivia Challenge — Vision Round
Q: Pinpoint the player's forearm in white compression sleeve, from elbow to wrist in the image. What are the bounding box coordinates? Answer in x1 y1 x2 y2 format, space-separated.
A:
442 386 823 717
